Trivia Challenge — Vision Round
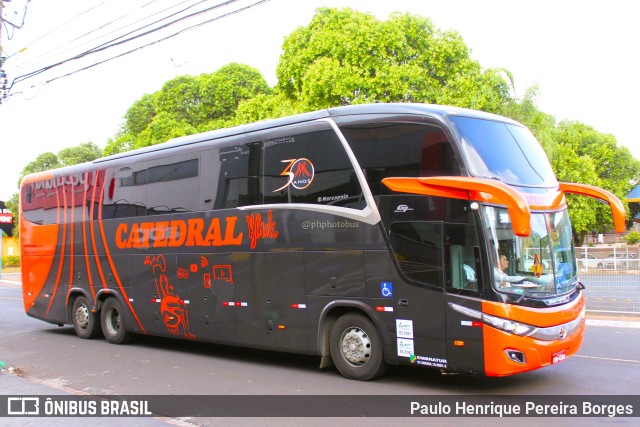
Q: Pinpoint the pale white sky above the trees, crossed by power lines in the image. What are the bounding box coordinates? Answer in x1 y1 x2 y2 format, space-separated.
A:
0 0 640 200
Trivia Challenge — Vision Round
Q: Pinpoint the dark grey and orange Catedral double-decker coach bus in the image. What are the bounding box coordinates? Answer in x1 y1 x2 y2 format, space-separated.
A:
20 104 625 380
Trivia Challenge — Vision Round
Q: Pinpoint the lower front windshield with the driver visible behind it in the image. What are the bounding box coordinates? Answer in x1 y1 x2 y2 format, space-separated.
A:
483 206 578 298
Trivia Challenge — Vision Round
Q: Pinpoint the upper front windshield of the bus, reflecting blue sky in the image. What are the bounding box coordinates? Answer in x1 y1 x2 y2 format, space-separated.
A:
451 117 558 186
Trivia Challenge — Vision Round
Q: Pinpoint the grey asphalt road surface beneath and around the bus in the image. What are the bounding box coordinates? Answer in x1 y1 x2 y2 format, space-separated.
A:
0 278 640 426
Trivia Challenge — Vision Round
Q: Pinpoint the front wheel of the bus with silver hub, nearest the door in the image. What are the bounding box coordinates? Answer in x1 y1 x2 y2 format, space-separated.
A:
330 313 387 381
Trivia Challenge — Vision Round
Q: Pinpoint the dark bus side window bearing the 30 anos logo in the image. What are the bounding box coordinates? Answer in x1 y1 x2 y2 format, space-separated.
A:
263 125 364 209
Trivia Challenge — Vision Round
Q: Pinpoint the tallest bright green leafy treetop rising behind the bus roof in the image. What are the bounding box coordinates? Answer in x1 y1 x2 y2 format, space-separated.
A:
277 8 510 111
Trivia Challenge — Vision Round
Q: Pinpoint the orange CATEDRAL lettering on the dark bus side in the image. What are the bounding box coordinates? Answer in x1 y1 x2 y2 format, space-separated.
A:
116 217 244 249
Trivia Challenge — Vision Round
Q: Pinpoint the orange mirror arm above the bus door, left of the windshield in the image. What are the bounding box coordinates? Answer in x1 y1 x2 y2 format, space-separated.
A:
382 176 531 236
